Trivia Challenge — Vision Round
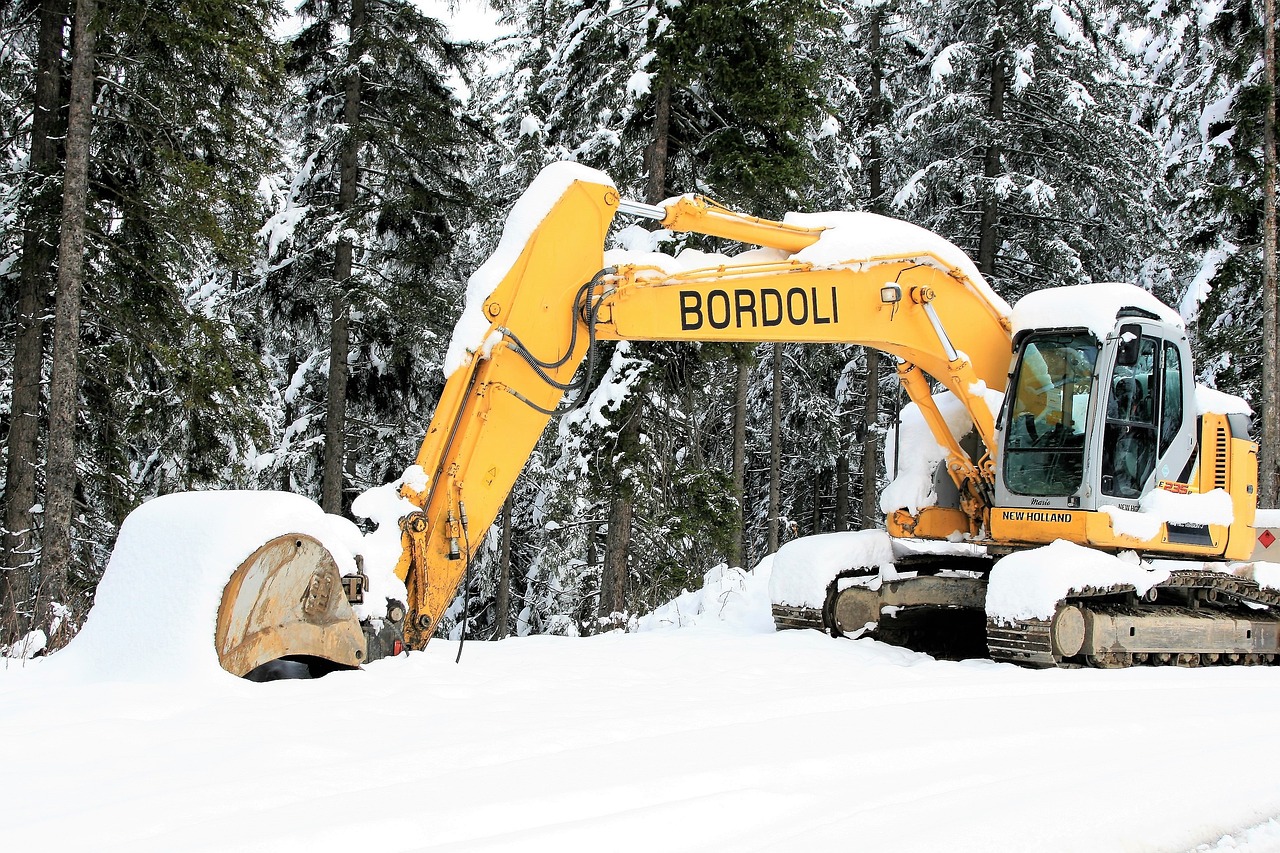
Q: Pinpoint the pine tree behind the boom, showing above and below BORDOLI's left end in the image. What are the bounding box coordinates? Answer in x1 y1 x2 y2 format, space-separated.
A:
476 1 817 625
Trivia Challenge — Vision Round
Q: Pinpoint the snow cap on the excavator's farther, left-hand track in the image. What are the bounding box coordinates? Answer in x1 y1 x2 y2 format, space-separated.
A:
769 530 893 608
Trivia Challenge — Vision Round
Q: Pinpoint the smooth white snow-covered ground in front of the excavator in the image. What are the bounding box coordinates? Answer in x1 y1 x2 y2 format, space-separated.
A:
0 565 1280 853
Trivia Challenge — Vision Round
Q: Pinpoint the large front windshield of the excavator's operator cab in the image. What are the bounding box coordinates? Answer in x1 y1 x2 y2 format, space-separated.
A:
1005 334 1098 497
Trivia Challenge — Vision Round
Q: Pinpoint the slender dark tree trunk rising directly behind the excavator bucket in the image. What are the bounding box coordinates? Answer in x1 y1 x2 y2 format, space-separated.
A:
320 0 365 515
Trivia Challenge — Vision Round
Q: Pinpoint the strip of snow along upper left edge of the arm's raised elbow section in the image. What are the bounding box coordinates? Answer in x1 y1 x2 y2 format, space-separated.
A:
444 161 613 377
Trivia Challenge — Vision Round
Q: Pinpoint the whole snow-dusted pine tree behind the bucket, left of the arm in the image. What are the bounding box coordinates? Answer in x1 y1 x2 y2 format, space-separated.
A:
257 0 480 505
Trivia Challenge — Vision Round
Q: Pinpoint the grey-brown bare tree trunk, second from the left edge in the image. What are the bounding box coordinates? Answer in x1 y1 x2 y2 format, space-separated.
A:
36 0 96 619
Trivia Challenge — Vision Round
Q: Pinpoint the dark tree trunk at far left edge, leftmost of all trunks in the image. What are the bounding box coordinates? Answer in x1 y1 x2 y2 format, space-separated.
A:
0 0 67 642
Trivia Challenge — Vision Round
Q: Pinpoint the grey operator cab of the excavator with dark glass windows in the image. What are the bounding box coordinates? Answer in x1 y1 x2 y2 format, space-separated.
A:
996 284 1196 510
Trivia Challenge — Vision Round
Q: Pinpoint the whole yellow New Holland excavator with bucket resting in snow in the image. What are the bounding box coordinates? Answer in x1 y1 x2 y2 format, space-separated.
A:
215 163 1280 675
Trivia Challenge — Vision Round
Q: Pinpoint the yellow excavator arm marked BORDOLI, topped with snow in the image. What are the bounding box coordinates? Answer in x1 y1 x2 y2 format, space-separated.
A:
397 164 1010 648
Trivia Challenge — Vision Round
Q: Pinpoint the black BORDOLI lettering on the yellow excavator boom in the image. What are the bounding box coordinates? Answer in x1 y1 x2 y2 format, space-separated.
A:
680 287 840 326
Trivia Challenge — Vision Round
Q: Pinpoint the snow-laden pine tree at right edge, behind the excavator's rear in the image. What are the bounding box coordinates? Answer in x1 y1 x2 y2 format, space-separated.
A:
1146 0 1275 499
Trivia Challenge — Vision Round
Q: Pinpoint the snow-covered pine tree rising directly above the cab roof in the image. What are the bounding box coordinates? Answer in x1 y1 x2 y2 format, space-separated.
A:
893 0 1164 301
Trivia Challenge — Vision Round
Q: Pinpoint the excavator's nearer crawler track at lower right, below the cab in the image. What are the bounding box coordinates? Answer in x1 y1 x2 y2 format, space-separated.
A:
987 570 1280 669
